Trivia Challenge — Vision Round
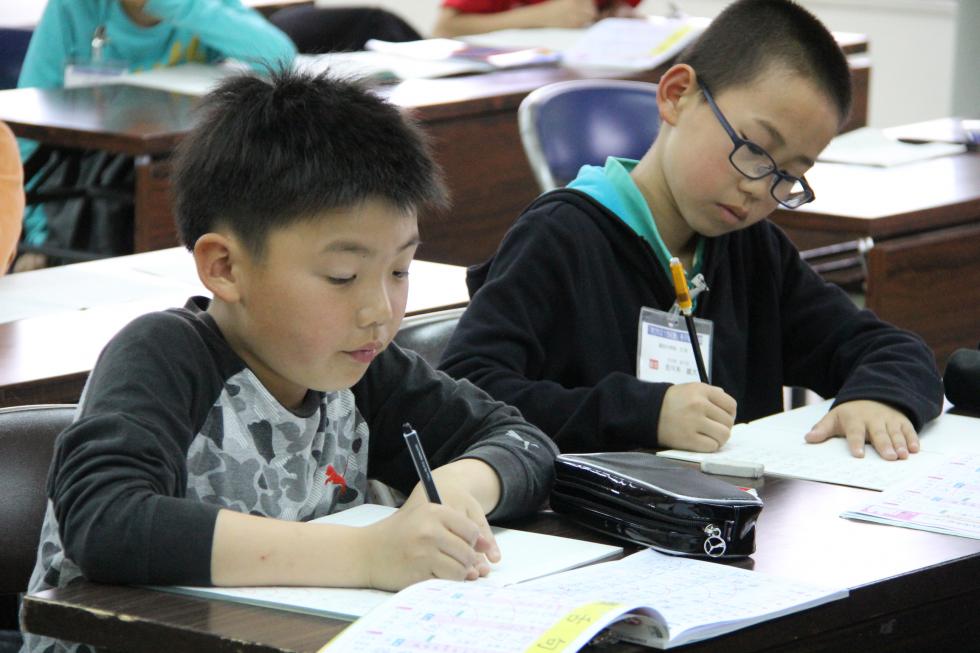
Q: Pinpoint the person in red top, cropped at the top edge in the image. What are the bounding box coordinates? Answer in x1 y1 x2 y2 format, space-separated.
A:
432 0 641 37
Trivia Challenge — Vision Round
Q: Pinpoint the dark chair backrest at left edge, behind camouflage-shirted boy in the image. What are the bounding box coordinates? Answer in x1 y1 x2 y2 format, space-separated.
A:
0 404 75 594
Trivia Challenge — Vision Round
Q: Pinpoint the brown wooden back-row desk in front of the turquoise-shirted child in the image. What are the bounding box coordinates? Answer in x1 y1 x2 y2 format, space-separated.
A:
0 34 870 265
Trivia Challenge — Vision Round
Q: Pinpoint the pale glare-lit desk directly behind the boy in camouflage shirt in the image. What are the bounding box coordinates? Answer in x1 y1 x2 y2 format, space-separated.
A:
0 248 469 407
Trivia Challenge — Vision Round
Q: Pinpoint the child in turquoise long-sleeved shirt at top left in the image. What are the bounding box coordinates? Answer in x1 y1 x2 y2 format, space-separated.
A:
17 0 296 267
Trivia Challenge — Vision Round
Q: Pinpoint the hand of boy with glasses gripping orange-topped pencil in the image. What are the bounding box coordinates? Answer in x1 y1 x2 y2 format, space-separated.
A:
657 383 738 453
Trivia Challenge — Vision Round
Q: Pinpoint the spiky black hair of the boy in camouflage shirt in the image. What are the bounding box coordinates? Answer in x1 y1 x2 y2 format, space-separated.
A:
173 70 446 258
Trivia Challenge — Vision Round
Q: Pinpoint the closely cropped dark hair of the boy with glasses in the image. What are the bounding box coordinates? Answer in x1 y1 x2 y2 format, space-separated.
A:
677 0 851 124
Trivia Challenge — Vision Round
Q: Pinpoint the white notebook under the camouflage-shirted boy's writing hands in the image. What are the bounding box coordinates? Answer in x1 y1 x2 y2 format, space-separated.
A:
153 504 623 619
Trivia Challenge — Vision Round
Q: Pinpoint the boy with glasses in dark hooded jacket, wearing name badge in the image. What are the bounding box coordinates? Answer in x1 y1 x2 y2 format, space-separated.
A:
441 0 942 460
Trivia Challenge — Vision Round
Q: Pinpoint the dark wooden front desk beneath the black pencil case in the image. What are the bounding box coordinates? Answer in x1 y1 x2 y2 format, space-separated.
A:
23 472 980 653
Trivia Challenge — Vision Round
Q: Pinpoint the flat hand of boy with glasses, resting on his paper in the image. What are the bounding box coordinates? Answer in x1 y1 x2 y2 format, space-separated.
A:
806 400 919 460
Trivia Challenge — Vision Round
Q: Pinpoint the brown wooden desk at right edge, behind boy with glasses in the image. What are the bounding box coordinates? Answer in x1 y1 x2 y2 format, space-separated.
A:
772 153 980 369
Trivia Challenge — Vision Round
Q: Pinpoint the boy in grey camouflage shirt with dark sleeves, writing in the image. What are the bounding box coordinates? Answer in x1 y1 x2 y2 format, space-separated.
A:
26 67 555 652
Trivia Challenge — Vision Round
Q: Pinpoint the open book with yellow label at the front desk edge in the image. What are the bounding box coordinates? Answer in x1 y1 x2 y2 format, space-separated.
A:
322 549 848 653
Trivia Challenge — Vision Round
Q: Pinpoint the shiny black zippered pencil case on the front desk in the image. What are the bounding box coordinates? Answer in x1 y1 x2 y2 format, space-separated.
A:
551 452 762 558
